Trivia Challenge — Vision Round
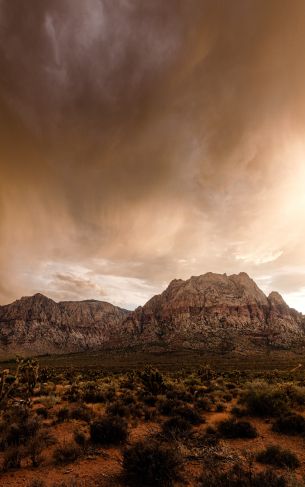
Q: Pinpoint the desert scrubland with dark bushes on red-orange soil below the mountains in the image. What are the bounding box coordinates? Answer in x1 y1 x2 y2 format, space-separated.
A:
0 360 305 487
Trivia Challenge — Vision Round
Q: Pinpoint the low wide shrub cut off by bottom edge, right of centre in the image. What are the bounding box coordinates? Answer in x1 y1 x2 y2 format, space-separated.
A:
199 465 288 487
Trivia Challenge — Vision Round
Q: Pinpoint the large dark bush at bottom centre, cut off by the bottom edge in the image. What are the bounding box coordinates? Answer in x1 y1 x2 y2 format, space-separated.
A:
123 441 181 487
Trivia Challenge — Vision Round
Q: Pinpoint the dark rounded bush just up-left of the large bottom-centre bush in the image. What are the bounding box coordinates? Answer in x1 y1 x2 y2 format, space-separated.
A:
90 416 128 445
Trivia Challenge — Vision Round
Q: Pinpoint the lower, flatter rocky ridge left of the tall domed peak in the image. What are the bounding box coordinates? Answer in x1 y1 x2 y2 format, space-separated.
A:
0 294 129 354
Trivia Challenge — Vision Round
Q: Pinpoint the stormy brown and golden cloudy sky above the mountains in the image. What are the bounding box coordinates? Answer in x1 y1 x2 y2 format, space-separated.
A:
0 0 305 312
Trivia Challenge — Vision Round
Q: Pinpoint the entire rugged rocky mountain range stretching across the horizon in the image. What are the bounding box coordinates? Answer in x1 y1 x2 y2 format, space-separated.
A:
0 272 305 356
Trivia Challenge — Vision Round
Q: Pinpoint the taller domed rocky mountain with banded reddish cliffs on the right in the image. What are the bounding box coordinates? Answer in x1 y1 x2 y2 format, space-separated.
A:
123 273 305 353
